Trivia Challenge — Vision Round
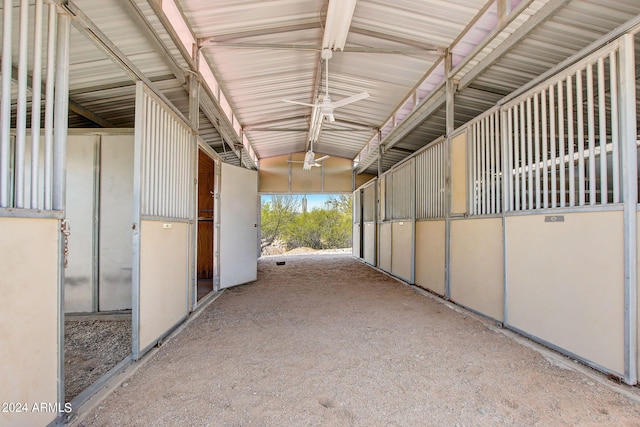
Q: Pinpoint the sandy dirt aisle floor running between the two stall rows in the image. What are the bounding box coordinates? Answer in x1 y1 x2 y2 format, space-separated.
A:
80 255 640 426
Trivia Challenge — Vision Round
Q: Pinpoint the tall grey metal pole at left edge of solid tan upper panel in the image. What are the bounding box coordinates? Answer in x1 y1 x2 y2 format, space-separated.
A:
444 51 455 299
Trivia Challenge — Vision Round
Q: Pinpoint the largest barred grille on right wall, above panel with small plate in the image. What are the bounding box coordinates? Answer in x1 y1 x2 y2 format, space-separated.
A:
503 44 621 211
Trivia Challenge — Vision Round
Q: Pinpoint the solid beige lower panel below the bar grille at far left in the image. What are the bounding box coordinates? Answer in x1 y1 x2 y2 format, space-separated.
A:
0 218 60 426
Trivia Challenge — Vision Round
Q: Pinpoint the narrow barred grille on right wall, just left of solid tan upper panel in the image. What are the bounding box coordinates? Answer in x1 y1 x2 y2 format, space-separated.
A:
415 140 446 219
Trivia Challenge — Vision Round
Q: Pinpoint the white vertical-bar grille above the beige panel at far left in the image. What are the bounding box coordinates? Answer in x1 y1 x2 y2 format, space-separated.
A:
0 0 61 211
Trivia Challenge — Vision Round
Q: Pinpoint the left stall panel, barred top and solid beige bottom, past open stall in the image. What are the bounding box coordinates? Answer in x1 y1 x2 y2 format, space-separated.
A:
132 82 197 359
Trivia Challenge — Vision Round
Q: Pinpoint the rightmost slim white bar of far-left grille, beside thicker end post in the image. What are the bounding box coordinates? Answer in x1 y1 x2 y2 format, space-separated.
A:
43 3 58 210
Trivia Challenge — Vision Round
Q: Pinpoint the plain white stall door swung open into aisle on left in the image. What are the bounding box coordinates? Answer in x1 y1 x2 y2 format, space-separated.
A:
220 163 259 289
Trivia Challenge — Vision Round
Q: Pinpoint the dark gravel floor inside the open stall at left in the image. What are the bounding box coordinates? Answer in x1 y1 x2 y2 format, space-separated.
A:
64 319 131 402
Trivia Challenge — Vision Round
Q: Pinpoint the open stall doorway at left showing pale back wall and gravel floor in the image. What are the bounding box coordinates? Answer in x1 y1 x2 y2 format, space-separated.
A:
58 129 134 400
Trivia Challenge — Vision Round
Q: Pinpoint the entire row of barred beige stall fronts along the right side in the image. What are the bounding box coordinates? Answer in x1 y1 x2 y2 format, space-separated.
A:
378 31 640 384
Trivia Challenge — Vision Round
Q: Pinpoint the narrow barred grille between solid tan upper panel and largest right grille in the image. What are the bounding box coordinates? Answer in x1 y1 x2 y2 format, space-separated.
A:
467 110 502 215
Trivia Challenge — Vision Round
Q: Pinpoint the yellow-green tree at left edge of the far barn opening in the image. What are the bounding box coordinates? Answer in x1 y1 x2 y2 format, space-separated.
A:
260 195 300 249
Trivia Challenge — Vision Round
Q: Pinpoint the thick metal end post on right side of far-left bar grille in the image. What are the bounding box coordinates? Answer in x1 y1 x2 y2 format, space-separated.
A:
53 9 71 210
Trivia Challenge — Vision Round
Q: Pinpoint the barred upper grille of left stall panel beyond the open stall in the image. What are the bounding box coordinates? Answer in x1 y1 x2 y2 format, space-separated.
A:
136 83 195 219
